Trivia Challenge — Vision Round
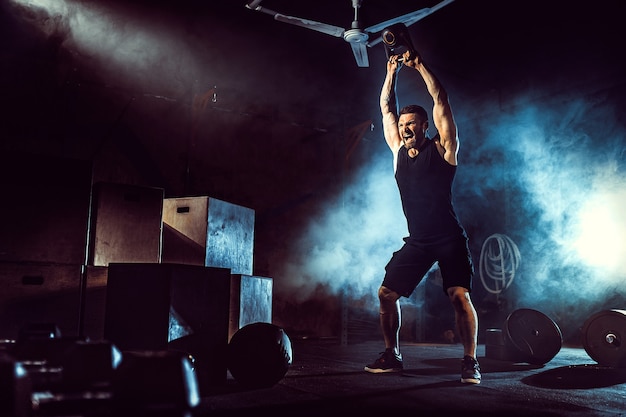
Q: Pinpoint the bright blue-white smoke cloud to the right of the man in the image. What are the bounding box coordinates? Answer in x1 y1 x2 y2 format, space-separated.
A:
490 99 626 299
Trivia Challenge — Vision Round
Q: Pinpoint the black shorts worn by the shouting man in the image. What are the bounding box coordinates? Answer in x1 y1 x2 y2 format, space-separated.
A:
382 236 474 297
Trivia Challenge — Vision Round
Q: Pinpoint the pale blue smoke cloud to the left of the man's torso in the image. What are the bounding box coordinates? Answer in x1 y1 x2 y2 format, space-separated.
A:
282 149 407 298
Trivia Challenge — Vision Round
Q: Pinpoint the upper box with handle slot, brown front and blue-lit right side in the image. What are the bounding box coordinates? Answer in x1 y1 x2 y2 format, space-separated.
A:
162 197 255 275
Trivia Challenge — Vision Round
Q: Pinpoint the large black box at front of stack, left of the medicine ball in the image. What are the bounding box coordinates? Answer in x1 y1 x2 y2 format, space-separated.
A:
104 263 230 389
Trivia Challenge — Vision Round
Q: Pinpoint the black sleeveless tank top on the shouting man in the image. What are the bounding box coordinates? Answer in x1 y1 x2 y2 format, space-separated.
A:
396 139 466 243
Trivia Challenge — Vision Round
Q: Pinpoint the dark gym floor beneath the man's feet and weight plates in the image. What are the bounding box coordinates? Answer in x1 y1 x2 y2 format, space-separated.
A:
195 340 626 416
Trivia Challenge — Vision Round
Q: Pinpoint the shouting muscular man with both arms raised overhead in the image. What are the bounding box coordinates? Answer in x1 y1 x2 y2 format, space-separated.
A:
365 51 481 384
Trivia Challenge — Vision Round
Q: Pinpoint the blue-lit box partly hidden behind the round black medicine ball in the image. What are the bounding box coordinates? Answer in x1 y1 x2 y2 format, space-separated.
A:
228 274 273 340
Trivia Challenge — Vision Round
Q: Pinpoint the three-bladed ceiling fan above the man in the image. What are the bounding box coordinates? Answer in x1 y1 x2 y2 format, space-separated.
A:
246 0 454 67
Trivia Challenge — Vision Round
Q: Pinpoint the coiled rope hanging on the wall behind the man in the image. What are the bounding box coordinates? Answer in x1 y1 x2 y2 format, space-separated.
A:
479 233 521 294
